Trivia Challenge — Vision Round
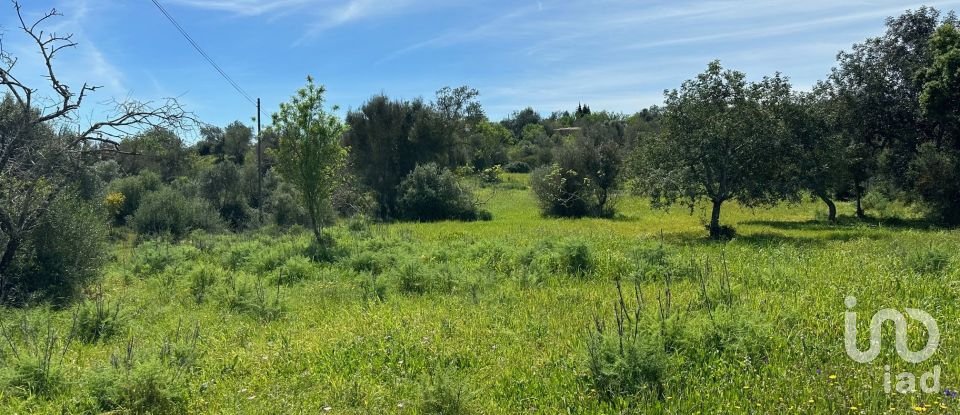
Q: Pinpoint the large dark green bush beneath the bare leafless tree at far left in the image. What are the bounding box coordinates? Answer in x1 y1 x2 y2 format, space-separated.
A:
3 193 107 302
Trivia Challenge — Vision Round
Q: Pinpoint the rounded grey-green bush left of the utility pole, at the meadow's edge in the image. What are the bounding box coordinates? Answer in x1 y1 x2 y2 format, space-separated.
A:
132 187 222 238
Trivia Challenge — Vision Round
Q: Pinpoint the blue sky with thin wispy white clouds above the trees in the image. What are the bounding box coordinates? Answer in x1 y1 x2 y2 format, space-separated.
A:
0 0 960 131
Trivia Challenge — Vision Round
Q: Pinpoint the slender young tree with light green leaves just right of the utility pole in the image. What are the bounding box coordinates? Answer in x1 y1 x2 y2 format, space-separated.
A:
273 77 347 242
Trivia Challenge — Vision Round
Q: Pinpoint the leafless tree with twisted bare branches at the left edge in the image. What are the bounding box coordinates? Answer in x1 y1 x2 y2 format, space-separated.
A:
0 1 194 302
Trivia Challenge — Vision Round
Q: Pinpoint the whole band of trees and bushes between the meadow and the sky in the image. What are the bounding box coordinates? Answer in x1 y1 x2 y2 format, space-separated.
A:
0 2 960 304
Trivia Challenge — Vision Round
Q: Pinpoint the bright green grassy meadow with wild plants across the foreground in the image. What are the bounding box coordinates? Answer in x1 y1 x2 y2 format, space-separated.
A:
0 176 960 414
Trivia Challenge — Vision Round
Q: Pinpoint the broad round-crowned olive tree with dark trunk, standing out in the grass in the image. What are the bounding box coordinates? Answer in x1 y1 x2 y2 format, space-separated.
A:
634 61 790 238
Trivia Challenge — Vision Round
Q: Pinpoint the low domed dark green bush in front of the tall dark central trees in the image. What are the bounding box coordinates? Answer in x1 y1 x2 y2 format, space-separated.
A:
397 163 489 221
